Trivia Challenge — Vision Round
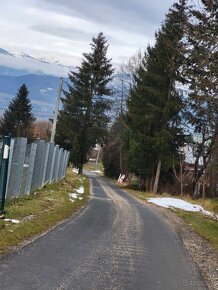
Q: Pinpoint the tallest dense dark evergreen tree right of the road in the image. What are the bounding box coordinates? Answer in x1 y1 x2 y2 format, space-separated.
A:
125 0 186 192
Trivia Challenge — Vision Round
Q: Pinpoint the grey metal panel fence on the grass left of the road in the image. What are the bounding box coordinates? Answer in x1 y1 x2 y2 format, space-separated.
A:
2 138 70 199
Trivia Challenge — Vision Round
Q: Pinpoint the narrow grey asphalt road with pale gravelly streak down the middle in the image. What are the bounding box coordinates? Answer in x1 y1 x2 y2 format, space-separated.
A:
0 174 207 290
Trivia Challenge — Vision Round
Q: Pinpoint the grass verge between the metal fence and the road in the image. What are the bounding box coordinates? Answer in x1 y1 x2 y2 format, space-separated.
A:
0 169 89 255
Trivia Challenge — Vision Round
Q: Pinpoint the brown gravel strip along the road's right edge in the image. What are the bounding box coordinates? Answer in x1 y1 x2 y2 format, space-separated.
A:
150 205 218 290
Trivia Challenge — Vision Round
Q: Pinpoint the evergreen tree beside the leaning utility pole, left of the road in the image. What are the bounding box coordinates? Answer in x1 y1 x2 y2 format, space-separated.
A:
57 33 113 173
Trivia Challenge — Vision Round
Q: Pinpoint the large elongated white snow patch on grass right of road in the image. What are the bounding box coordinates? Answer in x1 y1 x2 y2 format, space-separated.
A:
147 197 218 220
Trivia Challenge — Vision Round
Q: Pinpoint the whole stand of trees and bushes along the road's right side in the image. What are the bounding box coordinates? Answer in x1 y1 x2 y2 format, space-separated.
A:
103 0 218 199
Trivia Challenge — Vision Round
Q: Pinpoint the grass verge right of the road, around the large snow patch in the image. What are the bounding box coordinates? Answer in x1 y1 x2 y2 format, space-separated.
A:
116 183 218 251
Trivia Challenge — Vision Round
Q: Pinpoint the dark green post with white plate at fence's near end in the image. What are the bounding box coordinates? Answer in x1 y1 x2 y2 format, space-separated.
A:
0 136 11 214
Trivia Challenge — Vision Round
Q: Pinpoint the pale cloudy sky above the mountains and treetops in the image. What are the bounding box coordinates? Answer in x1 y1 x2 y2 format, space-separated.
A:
0 0 175 65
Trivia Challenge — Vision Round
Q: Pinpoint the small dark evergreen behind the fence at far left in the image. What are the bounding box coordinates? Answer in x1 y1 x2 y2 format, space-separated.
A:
0 84 35 137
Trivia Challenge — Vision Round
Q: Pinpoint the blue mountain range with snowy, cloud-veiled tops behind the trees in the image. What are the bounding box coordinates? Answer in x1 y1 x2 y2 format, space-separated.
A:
0 48 74 119
